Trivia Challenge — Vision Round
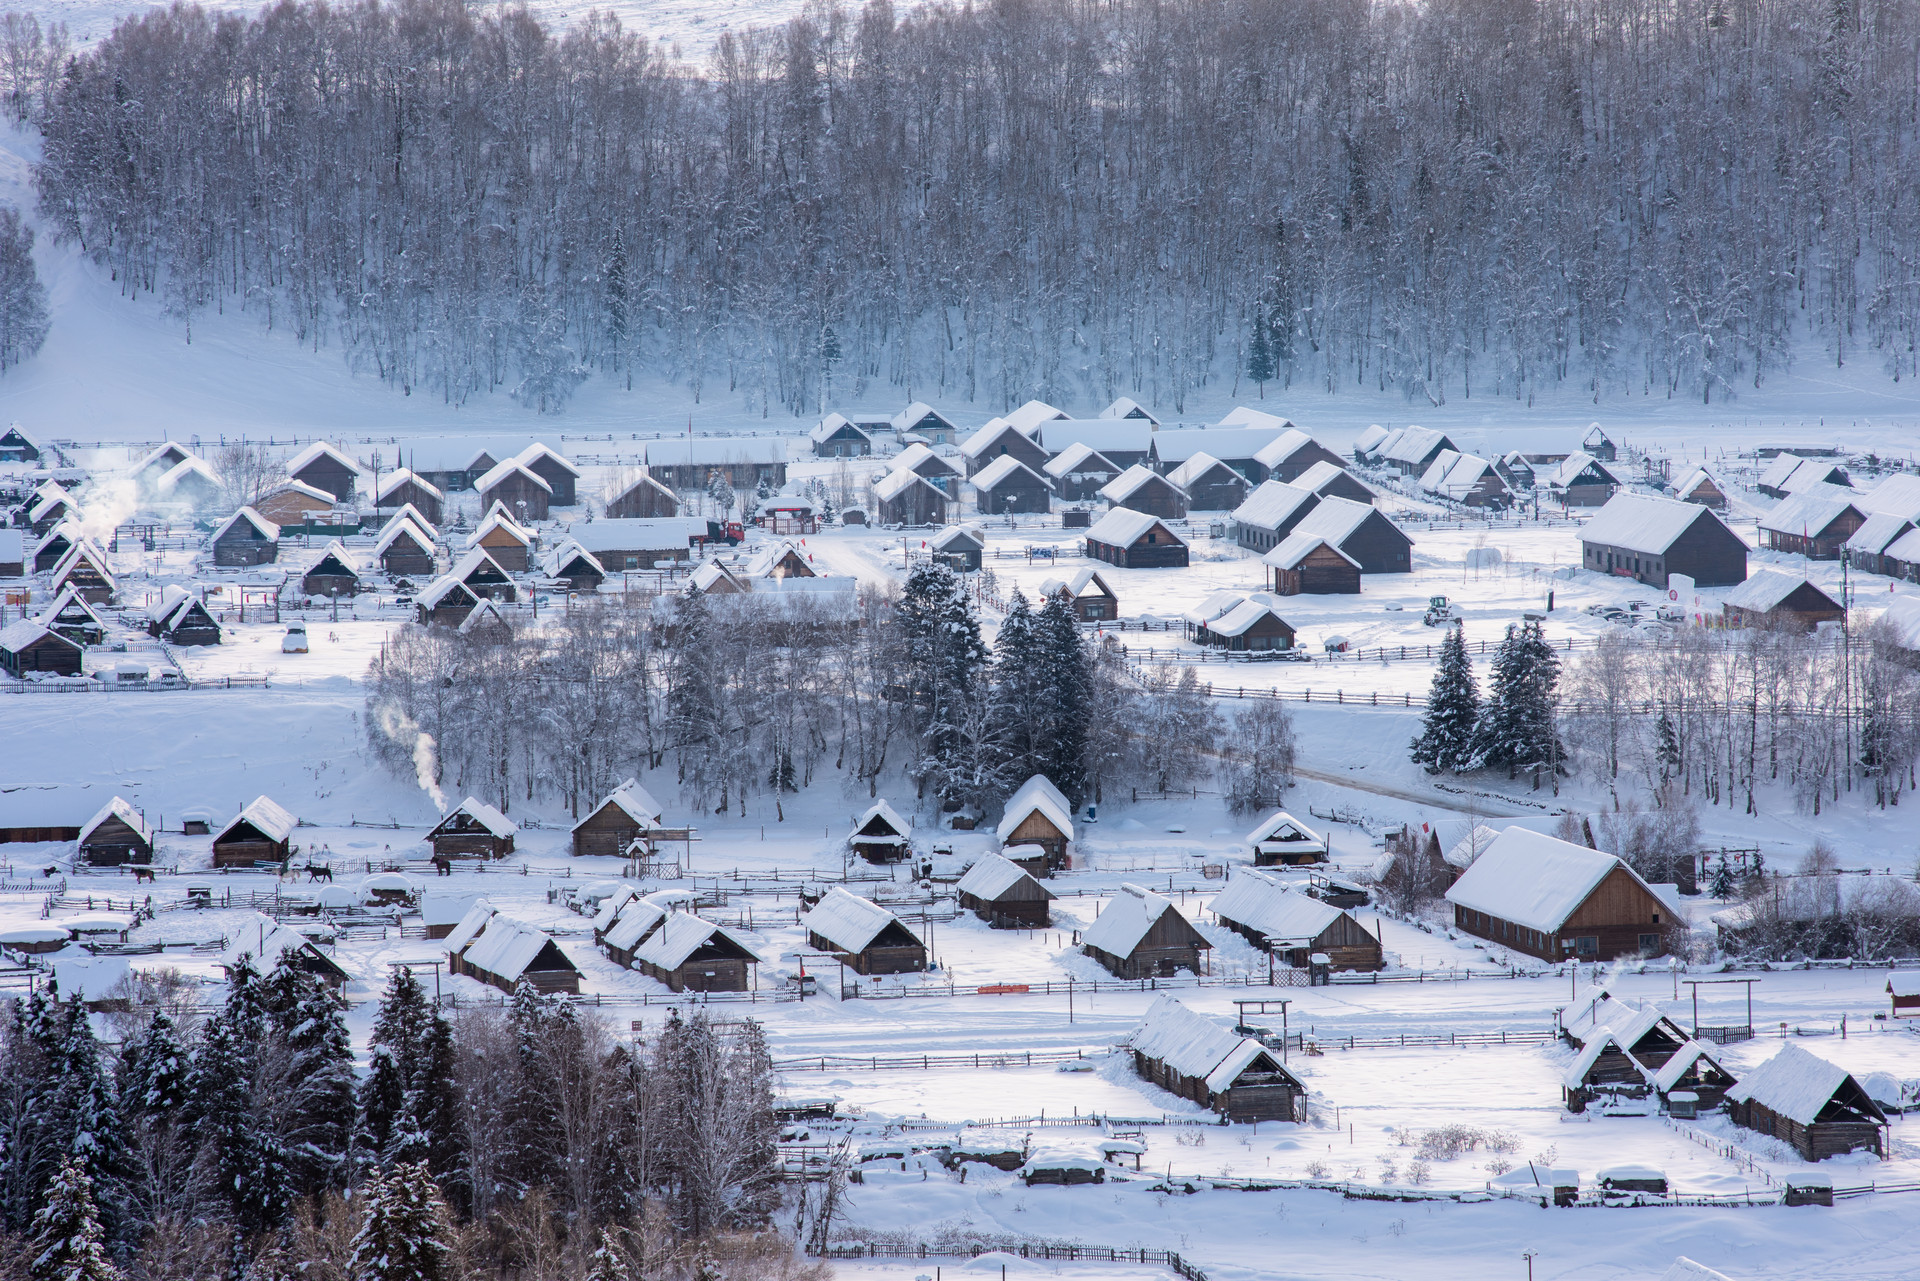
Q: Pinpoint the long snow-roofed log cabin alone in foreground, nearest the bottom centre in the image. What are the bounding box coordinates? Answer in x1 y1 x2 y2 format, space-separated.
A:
1127 997 1308 1124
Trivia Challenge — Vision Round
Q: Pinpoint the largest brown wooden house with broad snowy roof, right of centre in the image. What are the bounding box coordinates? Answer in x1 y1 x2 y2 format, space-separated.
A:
1446 828 1682 962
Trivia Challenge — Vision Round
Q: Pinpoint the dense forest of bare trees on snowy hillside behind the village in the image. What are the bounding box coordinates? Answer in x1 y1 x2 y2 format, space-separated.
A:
22 0 1920 411
